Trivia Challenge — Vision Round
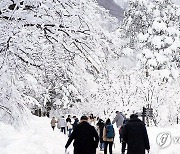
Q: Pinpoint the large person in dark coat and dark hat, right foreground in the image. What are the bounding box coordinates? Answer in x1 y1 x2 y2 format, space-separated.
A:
123 114 150 154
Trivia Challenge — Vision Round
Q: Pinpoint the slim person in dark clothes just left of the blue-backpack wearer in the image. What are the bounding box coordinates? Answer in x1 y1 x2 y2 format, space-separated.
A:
96 119 104 151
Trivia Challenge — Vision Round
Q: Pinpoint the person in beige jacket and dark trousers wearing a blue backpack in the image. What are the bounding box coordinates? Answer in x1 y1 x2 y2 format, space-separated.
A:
103 119 115 154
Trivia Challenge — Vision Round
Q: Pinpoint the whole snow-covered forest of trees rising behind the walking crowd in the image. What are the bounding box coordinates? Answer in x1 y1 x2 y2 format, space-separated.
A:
0 0 180 126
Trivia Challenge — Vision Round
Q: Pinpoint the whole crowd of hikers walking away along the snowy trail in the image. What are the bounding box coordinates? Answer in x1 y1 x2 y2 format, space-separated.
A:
51 111 150 154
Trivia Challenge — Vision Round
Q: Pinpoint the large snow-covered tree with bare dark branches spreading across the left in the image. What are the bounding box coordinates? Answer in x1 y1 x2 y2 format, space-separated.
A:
0 0 120 125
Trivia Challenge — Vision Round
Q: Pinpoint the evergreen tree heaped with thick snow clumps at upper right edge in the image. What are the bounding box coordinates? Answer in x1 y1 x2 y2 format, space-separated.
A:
138 1 179 80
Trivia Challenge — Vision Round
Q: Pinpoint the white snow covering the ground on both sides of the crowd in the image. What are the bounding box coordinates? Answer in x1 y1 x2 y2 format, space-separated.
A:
0 116 180 154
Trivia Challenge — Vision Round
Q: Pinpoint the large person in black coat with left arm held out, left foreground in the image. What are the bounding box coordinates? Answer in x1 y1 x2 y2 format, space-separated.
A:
65 116 99 154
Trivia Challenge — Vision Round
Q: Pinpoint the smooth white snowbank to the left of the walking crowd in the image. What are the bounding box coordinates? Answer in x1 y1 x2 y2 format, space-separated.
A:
0 116 73 154
